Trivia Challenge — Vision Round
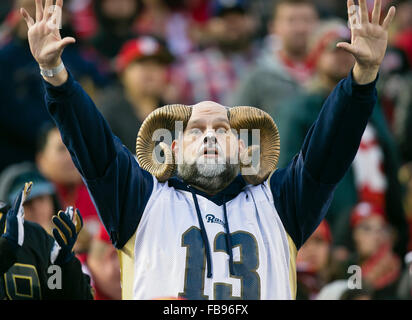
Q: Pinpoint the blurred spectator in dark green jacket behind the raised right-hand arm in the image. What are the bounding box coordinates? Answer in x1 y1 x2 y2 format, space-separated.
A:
277 21 409 260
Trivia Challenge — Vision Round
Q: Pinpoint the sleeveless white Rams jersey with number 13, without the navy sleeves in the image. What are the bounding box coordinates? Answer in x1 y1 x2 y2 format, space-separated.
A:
120 178 296 299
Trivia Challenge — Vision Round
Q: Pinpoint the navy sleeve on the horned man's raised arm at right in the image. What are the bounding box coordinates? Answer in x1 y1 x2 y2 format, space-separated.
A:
270 73 377 249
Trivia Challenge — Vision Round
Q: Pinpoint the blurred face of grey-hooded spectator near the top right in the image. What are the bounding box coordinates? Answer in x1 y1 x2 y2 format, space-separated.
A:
273 4 318 55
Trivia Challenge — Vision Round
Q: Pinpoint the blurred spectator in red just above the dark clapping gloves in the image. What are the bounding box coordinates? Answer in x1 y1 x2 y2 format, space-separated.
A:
36 124 100 254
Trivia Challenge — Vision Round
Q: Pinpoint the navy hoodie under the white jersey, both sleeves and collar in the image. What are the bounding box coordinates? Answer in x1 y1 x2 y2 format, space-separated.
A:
44 70 376 249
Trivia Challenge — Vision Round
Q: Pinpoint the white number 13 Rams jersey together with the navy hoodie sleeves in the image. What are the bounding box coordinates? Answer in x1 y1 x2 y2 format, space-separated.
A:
44 64 376 299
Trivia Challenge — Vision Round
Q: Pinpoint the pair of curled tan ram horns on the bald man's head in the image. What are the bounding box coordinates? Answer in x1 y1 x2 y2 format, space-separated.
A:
136 104 280 185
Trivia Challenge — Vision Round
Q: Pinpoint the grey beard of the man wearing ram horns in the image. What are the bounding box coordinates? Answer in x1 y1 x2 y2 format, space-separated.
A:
177 157 240 194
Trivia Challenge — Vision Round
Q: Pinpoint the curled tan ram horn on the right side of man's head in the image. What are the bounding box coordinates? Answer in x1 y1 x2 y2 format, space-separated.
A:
229 106 280 185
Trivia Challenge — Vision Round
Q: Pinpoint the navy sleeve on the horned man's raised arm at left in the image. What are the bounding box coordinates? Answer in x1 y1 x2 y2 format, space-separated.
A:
44 73 153 249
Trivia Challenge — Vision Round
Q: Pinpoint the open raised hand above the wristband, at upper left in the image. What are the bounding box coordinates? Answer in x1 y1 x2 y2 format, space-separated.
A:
20 0 76 69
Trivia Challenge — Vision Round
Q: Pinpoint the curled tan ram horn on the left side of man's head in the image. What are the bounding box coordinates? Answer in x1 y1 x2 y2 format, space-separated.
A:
136 104 192 182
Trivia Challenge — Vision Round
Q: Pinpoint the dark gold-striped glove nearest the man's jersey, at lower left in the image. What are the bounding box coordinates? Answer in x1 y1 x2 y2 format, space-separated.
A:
50 207 83 265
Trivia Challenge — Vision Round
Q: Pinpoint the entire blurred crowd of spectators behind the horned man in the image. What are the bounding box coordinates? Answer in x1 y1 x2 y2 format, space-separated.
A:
0 0 412 300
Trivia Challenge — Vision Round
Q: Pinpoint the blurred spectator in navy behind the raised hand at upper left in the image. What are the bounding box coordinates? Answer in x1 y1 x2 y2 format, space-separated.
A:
0 0 106 172
